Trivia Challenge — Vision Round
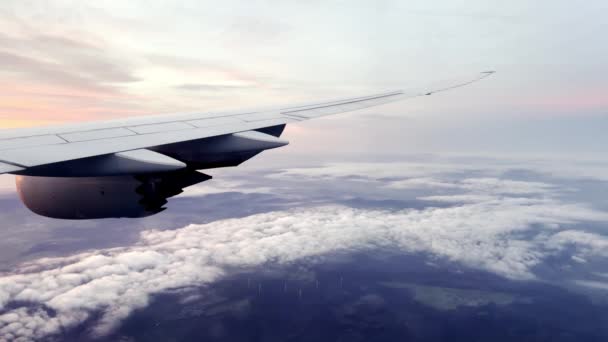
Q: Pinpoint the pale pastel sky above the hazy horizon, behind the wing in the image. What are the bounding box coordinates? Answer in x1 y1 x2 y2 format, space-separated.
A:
0 0 608 157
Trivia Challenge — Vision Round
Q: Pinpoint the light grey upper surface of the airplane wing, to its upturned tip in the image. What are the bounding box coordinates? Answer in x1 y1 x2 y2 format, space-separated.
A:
0 72 492 173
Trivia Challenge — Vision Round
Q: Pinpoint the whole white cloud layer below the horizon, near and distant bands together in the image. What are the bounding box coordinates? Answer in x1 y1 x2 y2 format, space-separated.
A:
0 156 608 341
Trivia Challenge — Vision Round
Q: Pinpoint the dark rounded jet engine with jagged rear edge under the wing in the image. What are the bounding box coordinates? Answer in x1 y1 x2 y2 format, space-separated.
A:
16 169 211 220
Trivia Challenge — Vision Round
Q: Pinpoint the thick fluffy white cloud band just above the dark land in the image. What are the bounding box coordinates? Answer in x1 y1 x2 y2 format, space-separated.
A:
0 186 608 340
